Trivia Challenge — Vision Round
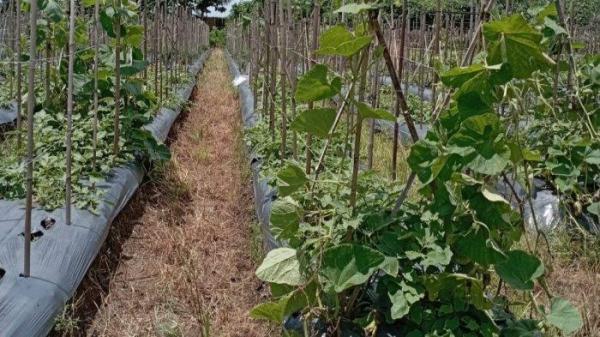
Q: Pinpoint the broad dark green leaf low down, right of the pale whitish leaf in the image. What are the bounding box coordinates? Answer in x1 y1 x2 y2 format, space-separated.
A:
321 244 385 293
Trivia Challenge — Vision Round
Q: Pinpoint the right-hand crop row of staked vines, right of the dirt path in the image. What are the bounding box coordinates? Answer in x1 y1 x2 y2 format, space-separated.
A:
225 0 600 337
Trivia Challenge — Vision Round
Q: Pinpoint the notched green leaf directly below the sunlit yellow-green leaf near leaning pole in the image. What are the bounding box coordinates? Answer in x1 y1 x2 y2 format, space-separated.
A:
296 64 342 103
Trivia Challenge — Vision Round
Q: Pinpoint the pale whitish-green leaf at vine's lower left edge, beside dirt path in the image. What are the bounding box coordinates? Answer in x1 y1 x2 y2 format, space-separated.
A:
256 248 304 286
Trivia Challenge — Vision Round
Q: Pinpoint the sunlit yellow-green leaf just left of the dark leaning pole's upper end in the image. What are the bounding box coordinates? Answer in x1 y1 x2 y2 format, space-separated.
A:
317 25 372 57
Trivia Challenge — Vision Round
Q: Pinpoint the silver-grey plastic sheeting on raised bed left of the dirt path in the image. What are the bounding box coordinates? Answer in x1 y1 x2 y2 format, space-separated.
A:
0 53 208 337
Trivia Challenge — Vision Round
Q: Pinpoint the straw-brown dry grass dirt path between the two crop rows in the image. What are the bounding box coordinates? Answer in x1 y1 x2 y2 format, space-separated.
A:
55 50 271 337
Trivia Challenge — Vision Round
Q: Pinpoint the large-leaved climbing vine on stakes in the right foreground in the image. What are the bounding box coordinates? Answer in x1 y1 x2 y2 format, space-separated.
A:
232 3 600 337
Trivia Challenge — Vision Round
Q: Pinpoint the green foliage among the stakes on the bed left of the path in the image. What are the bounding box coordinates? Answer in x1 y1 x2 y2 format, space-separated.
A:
0 0 197 211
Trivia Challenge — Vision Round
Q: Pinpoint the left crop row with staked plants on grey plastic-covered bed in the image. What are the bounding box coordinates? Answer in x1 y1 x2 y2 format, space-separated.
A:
0 0 209 337
